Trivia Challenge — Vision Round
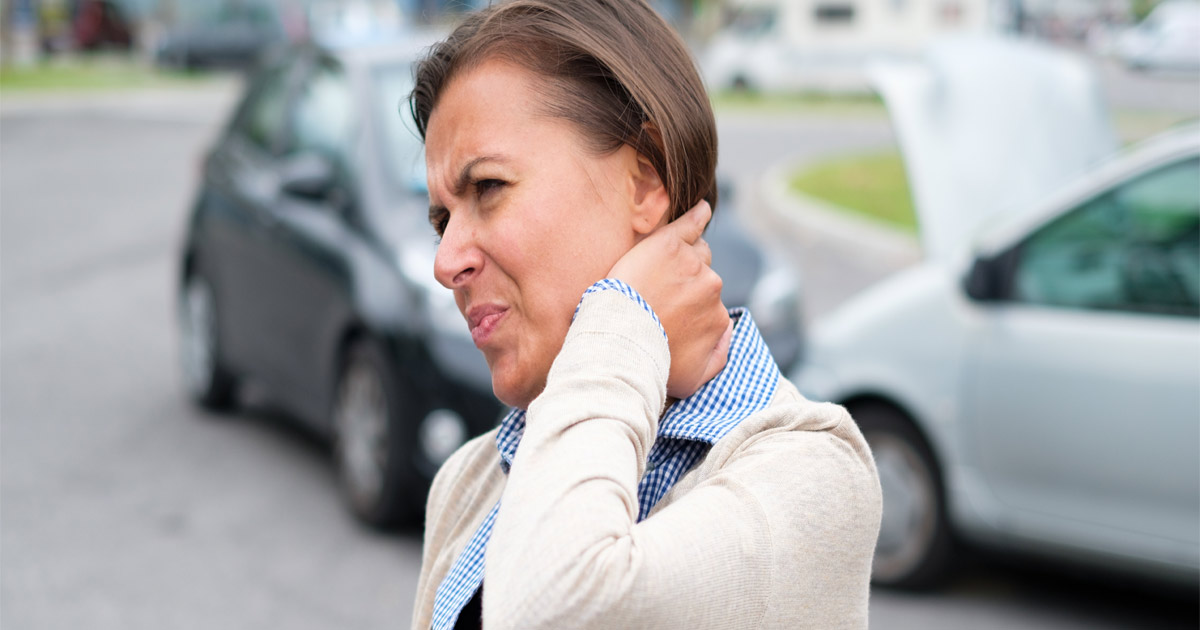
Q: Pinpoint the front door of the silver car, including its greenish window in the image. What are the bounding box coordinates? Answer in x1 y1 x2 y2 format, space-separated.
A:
964 156 1200 570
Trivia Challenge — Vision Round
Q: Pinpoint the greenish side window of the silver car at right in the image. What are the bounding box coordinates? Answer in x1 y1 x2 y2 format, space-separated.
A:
1013 158 1200 317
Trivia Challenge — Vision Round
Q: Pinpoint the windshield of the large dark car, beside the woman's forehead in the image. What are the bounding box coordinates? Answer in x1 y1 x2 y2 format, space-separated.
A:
371 64 427 194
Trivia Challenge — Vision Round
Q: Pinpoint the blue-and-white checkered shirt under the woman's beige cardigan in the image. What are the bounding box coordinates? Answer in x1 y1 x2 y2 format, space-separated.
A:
433 278 780 630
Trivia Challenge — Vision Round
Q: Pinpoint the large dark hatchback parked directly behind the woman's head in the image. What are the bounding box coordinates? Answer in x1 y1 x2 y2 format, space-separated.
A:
179 36 799 526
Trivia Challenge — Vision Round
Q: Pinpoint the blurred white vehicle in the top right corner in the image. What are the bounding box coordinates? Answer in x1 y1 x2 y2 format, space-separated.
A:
1116 0 1200 73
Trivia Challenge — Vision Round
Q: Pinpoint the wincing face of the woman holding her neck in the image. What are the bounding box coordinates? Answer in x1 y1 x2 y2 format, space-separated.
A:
426 60 641 408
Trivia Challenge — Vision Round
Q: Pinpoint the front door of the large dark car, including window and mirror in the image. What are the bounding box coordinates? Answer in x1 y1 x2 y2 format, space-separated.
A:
243 58 359 418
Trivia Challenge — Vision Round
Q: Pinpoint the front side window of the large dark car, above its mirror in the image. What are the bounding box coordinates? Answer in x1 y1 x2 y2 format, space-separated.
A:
290 60 354 167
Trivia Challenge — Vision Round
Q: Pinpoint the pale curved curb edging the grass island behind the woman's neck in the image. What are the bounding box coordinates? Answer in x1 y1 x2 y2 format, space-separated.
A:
758 160 924 268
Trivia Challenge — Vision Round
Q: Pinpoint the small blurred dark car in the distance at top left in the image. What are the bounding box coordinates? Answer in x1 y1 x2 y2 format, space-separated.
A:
155 4 286 71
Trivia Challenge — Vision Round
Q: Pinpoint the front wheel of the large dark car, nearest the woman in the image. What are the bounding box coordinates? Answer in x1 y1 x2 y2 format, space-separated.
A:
334 338 424 528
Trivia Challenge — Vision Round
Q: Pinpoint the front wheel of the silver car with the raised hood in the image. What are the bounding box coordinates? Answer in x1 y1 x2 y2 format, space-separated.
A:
851 403 953 588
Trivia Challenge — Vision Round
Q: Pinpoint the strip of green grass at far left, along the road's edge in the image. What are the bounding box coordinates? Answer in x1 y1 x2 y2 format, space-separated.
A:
0 55 209 94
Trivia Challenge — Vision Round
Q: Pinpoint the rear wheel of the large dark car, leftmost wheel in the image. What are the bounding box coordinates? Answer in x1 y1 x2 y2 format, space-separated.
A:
179 272 238 410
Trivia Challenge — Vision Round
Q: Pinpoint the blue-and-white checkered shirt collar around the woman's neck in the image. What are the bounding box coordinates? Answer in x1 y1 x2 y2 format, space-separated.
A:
496 307 780 473
